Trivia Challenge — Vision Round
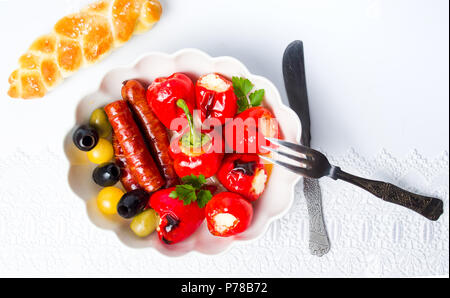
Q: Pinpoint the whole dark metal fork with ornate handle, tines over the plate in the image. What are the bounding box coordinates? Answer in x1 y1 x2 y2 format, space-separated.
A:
261 138 443 221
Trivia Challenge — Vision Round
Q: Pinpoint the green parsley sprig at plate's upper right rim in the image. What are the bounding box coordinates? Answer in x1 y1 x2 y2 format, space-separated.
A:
231 77 265 112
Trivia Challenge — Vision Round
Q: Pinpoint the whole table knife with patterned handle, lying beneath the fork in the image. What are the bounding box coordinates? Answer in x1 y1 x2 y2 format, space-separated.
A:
283 40 330 256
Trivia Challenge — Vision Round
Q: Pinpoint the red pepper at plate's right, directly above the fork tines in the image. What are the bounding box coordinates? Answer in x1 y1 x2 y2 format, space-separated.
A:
225 107 279 154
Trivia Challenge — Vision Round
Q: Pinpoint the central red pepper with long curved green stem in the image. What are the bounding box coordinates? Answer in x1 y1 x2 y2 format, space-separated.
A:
170 99 223 178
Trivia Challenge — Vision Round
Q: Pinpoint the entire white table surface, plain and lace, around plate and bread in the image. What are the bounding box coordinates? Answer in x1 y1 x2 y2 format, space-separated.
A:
0 0 449 277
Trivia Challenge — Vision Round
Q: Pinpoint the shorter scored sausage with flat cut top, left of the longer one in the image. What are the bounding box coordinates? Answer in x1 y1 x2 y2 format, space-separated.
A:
105 100 165 192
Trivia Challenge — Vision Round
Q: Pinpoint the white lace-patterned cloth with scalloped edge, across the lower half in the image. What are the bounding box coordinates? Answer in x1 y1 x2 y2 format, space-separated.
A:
0 150 449 277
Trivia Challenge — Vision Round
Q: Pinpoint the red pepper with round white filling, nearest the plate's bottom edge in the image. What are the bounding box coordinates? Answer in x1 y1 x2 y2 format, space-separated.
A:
205 192 253 237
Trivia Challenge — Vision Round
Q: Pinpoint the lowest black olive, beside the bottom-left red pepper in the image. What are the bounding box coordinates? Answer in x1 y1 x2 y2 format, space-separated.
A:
117 189 150 218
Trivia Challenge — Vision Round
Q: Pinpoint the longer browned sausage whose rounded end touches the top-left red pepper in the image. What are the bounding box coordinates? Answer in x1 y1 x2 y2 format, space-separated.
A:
122 80 179 188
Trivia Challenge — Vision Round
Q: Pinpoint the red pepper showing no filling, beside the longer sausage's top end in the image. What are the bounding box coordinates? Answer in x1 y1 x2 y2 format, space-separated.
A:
147 73 195 131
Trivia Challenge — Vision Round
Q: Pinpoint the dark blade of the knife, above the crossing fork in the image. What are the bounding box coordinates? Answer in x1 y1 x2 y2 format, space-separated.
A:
283 40 311 147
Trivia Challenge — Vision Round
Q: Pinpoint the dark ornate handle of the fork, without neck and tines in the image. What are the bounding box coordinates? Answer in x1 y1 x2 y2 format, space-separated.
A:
333 168 444 221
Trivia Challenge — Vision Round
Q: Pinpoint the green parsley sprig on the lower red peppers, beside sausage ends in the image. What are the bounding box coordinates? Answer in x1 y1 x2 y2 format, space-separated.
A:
169 174 212 208
